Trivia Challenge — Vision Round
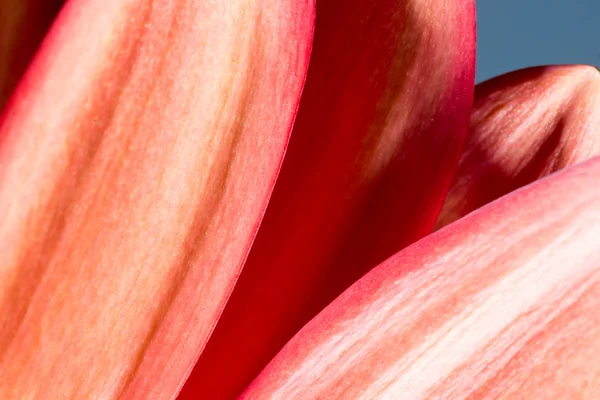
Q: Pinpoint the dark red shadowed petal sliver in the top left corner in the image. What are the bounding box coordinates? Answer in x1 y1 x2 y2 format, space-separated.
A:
0 0 64 111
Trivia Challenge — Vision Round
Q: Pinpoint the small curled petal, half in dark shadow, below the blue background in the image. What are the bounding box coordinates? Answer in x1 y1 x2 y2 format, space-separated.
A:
437 66 600 228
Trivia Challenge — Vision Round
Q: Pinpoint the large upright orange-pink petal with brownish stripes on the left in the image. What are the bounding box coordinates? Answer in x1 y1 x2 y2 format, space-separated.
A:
0 0 314 399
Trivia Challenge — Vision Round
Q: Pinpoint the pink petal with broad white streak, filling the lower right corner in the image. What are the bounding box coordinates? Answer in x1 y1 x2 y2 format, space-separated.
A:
242 158 600 400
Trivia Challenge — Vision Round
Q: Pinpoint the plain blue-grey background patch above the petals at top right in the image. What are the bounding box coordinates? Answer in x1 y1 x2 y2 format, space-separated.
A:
476 0 600 82
